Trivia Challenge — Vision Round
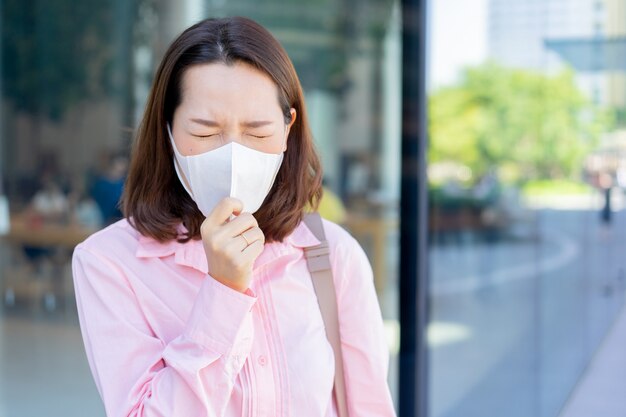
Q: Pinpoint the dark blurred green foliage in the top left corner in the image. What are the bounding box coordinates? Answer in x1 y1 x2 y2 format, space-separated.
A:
0 0 137 120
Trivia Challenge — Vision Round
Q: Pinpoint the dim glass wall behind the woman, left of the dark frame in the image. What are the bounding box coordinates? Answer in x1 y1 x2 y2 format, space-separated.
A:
0 0 401 416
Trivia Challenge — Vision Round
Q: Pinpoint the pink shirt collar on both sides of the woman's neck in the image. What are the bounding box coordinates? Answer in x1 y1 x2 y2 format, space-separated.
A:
135 222 320 274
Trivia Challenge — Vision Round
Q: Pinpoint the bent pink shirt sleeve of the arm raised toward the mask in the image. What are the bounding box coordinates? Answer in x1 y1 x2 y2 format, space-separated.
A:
72 246 256 417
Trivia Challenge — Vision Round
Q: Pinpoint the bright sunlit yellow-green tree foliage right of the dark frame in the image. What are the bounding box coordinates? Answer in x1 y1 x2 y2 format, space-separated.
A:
429 63 611 182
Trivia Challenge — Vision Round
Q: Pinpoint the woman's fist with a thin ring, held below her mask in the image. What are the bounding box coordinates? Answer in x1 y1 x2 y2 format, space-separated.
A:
200 198 265 292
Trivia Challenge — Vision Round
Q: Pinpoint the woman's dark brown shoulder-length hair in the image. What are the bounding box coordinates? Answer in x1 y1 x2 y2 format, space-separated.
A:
122 17 322 242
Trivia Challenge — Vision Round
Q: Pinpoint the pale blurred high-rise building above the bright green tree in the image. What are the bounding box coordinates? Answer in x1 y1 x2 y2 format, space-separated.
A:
488 0 626 106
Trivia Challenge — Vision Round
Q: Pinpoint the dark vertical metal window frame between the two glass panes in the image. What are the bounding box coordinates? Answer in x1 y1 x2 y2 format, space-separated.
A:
398 0 428 417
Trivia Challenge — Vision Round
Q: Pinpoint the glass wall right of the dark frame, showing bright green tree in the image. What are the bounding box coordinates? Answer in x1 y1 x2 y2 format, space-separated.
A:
428 0 626 417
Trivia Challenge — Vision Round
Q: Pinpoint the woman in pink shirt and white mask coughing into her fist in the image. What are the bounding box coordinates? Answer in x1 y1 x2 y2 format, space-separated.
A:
73 18 394 417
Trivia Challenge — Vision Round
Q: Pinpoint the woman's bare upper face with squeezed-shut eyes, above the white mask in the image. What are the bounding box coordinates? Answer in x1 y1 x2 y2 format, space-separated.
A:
171 63 296 155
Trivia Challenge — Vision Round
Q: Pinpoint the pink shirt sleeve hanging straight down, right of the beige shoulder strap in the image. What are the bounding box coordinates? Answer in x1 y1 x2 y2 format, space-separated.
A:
333 238 396 417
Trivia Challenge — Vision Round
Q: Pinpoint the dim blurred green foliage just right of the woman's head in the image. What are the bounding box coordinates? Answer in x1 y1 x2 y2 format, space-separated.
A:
207 0 393 96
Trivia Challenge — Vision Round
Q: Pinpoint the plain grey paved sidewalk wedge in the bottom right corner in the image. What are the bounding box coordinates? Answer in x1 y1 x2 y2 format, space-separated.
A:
560 308 626 417
